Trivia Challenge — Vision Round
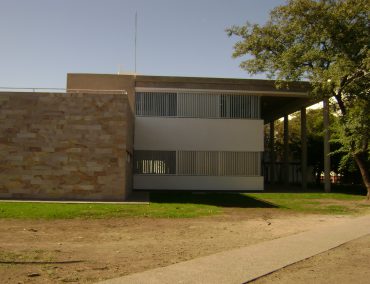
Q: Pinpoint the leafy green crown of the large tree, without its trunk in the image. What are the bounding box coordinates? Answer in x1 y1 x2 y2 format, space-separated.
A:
227 0 370 94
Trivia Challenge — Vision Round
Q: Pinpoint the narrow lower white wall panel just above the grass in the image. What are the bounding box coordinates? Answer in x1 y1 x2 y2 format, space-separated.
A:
134 175 263 191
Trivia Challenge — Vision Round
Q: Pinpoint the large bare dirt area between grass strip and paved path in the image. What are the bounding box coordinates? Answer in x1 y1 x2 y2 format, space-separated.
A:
0 208 364 283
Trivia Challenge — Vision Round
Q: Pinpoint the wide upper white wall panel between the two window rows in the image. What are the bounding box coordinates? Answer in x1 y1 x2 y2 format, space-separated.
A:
134 117 264 152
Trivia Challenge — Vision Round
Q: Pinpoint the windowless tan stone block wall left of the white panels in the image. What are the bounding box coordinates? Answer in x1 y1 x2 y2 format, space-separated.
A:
0 92 134 200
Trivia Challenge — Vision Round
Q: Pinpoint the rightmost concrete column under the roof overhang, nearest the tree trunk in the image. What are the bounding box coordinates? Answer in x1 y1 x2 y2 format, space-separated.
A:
323 98 331 192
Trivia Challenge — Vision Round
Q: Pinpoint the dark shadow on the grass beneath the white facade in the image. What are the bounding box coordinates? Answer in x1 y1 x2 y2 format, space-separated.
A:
150 191 278 208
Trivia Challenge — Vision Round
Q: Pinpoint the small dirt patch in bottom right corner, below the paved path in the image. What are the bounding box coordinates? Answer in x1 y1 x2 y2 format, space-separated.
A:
250 235 370 284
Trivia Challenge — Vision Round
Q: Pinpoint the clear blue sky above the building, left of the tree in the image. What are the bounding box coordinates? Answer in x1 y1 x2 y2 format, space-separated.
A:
0 0 284 88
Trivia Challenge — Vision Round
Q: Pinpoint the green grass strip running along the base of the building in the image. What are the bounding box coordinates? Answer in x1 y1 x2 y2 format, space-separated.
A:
0 192 370 219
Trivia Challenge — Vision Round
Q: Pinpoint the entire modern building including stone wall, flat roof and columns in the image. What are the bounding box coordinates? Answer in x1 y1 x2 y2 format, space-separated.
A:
0 74 330 200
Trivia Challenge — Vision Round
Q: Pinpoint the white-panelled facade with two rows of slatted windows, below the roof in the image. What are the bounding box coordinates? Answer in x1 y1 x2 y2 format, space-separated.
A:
133 88 263 190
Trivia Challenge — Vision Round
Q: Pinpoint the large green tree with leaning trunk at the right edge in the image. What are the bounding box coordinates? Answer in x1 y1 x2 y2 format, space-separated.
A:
227 0 370 198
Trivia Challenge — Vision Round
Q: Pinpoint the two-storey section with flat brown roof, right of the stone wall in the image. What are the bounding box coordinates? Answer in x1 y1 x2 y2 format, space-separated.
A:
68 74 309 196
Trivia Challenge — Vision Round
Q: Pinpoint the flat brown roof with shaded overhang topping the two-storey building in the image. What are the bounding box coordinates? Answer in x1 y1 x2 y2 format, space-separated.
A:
67 73 320 123
